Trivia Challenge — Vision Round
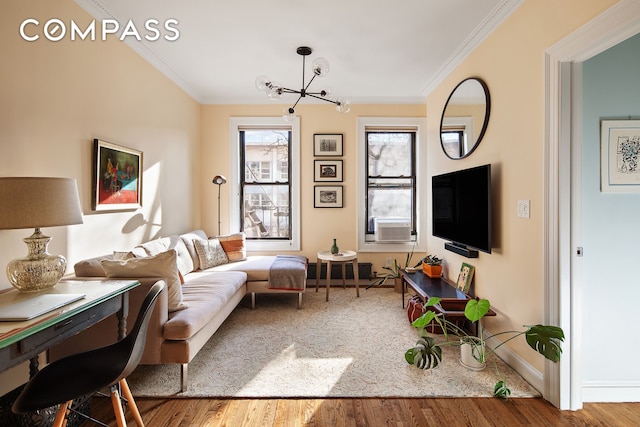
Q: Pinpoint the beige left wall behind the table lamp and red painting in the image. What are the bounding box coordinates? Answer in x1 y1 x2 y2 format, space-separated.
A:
0 0 200 394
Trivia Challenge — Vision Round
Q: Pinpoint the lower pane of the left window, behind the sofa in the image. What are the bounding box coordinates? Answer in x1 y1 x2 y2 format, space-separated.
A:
242 185 291 239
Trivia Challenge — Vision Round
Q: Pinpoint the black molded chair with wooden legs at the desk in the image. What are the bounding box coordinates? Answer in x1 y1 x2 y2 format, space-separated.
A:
12 282 165 427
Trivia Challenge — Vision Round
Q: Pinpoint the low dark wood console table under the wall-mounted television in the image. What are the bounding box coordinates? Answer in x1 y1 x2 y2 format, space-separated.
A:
400 270 496 335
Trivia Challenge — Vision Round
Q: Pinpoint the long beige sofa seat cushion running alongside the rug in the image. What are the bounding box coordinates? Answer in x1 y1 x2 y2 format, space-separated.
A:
163 271 247 340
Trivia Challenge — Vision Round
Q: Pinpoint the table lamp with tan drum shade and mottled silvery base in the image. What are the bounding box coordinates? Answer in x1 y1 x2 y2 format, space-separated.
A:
0 177 82 292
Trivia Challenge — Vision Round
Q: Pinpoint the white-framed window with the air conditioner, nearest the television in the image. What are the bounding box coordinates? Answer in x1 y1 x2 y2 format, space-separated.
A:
357 117 427 252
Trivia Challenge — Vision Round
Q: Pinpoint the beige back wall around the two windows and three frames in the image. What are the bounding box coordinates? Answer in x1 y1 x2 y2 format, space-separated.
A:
201 104 426 271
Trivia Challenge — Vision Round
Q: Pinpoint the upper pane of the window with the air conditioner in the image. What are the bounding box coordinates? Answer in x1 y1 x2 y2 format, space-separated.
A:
367 132 413 176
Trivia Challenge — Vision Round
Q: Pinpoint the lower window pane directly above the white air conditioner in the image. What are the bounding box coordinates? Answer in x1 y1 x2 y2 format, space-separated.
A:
367 187 414 233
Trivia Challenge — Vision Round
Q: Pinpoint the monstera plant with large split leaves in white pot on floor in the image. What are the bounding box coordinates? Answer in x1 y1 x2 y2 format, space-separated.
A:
405 297 564 399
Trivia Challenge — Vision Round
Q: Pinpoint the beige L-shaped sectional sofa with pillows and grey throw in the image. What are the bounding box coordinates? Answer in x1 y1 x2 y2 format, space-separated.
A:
49 230 308 391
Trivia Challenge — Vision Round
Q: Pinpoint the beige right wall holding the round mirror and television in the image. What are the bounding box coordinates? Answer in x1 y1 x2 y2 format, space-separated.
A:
427 0 615 371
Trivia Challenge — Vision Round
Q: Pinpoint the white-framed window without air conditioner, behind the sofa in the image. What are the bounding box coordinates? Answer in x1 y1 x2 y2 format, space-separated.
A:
229 118 300 250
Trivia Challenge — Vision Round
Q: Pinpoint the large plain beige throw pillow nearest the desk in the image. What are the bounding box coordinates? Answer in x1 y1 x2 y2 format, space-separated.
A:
101 249 187 312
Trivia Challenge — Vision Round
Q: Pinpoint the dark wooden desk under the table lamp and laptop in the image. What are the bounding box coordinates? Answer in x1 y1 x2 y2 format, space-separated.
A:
0 280 140 375
